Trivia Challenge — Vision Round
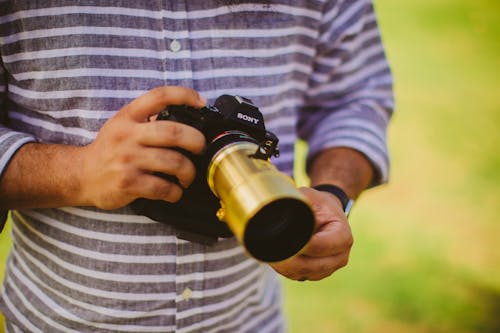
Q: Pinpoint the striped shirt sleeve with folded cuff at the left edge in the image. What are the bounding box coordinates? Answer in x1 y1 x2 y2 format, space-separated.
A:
0 54 36 227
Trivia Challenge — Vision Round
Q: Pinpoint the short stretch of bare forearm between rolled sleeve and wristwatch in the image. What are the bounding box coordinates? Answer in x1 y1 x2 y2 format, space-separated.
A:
309 148 374 199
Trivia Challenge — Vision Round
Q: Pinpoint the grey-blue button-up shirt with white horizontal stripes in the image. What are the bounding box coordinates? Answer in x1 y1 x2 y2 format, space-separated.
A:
0 0 393 332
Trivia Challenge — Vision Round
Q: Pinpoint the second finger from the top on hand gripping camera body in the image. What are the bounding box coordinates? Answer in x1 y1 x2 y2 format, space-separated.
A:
138 121 205 154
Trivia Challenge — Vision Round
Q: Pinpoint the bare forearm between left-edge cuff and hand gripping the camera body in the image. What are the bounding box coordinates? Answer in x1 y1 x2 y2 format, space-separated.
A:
0 143 85 209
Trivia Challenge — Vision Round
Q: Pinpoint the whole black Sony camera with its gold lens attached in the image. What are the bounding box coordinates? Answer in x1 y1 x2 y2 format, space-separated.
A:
132 95 314 262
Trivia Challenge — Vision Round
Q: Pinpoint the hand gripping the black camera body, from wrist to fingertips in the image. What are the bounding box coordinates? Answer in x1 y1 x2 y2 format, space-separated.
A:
82 86 206 209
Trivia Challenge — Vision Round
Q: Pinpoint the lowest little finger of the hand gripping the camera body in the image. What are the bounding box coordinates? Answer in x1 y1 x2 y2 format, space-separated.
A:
129 173 183 202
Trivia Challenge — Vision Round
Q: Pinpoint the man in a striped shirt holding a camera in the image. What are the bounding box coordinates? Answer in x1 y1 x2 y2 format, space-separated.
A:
0 0 392 332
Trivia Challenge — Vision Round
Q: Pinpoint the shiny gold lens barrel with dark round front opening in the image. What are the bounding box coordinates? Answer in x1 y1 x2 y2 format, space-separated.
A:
207 142 314 262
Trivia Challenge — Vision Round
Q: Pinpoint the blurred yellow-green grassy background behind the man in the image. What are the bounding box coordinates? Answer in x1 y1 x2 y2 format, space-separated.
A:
0 0 500 333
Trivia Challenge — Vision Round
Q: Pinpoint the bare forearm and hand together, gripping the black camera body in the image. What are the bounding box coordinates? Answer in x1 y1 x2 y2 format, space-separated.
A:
0 87 206 209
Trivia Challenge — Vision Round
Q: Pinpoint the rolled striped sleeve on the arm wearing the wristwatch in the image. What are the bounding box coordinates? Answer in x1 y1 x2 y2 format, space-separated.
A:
298 0 394 186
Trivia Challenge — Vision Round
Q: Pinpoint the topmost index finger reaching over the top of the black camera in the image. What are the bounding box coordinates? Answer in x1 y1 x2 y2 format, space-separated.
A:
122 86 206 122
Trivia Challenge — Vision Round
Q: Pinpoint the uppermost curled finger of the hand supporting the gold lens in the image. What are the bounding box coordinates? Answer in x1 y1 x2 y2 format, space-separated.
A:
300 222 354 258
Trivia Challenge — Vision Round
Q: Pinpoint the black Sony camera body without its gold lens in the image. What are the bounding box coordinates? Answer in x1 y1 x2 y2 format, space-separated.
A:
132 95 279 244
